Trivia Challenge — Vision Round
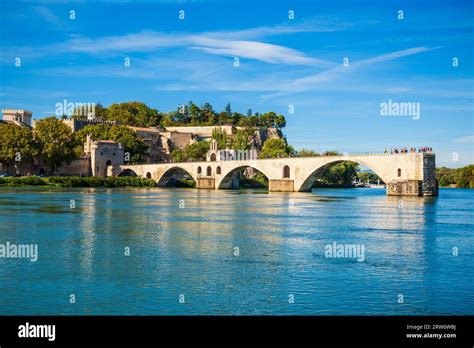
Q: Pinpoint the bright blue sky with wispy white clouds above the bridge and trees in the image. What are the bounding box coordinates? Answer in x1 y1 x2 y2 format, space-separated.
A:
0 0 474 167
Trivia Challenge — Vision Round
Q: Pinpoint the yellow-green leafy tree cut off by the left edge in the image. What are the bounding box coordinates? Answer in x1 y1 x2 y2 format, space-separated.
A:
0 123 38 174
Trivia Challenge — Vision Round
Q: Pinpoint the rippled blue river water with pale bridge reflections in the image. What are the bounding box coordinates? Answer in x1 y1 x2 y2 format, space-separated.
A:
0 187 474 315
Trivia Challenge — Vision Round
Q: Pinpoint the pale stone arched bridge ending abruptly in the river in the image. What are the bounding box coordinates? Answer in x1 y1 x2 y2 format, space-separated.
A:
107 153 438 196
